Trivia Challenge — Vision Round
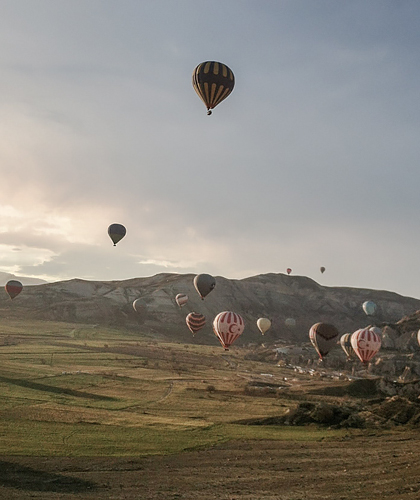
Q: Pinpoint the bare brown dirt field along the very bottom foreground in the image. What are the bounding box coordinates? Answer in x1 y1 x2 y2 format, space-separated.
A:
0 431 420 500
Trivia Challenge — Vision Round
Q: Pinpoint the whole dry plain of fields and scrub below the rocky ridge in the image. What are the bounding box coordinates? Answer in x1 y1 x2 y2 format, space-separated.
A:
0 312 420 500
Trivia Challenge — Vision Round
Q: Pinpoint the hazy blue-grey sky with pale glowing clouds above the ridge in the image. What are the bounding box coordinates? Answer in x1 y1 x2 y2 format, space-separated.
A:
0 0 420 298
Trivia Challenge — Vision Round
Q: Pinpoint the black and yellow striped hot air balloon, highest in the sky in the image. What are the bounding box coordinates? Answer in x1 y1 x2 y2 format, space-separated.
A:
192 61 235 115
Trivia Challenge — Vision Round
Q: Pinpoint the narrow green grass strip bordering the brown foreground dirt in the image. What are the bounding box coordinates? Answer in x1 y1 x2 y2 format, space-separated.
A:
0 419 345 457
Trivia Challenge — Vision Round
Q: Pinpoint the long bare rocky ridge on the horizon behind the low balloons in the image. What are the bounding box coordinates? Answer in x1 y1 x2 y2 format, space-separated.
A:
0 274 420 343
